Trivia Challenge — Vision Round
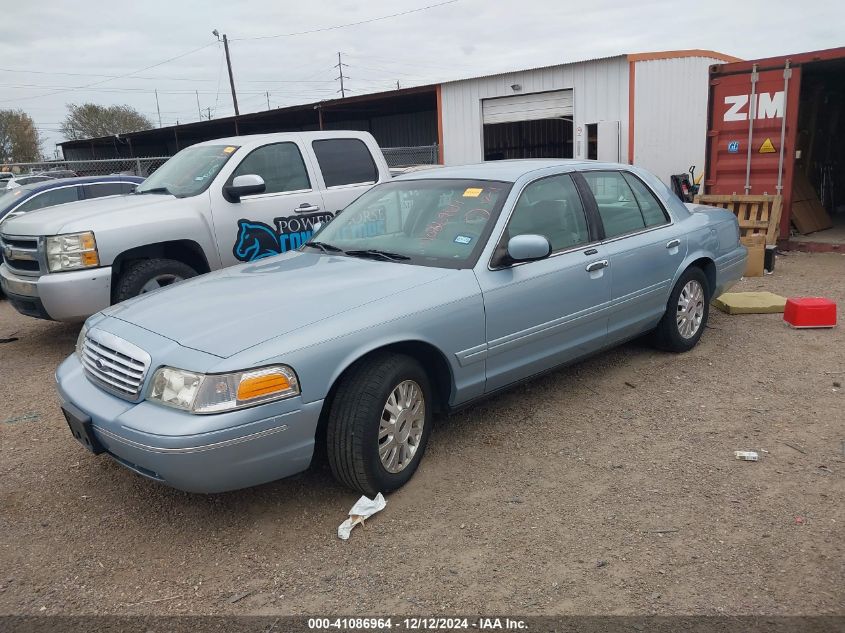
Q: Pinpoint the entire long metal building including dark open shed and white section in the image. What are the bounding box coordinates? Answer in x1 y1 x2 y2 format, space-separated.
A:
56 50 738 183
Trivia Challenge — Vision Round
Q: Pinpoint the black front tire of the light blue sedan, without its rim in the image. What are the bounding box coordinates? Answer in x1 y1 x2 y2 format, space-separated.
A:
326 353 435 497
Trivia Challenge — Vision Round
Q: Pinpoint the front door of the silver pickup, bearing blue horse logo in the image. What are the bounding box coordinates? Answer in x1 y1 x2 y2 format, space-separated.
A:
211 141 326 266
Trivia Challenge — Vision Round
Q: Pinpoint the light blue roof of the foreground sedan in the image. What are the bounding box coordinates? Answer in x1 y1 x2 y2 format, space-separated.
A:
394 158 630 182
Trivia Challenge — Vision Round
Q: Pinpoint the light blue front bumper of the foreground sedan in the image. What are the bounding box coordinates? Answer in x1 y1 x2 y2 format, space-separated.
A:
56 356 323 493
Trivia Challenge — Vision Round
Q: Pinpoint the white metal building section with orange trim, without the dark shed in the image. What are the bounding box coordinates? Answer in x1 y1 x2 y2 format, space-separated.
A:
438 50 737 182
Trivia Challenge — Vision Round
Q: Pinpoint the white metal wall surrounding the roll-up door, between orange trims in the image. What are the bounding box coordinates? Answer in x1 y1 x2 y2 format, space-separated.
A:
441 55 628 165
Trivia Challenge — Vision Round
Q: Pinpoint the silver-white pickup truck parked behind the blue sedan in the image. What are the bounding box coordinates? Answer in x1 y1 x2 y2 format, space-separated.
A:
0 131 390 321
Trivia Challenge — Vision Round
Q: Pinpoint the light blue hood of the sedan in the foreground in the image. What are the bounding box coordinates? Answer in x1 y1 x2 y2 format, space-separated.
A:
104 251 458 358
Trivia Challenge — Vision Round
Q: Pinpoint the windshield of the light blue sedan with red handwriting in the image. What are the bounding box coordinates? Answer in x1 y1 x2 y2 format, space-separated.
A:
304 179 511 268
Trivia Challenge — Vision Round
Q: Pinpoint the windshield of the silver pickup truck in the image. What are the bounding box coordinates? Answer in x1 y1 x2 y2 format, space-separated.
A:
135 145 238 198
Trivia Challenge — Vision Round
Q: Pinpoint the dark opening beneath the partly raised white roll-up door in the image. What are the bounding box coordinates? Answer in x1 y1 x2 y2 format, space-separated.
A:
484 118 574 160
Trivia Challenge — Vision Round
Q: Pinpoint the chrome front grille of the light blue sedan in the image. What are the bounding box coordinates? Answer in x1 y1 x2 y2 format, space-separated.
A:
81 329 151 400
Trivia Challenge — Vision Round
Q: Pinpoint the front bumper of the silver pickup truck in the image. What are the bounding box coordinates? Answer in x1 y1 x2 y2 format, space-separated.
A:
0 264 111 321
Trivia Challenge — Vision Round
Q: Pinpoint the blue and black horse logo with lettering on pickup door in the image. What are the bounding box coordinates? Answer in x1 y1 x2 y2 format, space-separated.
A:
232 213 334 262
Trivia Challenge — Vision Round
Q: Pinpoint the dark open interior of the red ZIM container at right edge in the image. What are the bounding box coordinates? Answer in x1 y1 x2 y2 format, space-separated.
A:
791 59 845 244
